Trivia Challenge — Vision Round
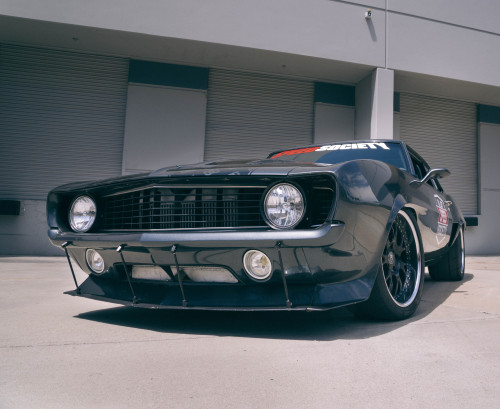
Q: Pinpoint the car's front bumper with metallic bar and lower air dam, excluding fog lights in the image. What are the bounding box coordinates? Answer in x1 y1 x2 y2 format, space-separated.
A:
49 223 378 310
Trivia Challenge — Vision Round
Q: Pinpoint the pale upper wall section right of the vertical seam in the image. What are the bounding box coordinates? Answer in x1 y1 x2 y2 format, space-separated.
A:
387 5 500 87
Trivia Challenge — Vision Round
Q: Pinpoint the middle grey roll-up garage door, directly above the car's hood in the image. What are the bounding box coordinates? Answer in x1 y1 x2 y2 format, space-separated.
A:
205 70 314 160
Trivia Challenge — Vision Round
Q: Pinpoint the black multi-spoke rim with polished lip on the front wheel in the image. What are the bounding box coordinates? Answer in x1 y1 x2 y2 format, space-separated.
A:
382 211 422 307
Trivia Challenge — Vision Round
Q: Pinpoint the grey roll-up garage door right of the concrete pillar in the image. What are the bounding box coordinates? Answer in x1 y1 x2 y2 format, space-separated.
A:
400 94 478 214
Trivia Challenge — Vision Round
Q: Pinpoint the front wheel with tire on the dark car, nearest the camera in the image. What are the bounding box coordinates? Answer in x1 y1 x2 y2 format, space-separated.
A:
359 210 424 321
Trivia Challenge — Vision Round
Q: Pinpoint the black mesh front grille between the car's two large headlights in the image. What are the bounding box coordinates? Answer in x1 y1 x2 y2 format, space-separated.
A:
102 187 266 230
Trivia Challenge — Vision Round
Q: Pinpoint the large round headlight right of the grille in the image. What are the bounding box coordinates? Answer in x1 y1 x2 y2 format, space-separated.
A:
264 183 305 229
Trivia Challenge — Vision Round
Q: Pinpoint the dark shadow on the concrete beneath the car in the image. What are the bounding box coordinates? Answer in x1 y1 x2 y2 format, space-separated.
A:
76 274 474 341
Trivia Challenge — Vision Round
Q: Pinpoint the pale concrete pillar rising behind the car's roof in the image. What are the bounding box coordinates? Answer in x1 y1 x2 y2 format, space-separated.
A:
355 68 394 139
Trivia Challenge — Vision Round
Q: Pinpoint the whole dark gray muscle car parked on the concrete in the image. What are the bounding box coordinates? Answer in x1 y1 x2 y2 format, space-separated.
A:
47 140 465 320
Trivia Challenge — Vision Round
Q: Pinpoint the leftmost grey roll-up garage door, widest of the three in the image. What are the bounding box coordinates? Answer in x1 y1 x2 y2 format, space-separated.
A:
0 44 128 199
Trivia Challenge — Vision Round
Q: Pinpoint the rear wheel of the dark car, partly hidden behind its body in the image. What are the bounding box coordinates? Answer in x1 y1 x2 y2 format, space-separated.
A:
429 227 465 281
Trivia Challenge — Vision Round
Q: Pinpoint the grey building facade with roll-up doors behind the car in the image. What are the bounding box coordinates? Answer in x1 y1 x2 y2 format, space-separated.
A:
0 0 500 255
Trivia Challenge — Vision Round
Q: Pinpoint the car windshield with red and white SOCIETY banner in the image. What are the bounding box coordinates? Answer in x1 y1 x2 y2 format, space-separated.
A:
269 142 408 171
